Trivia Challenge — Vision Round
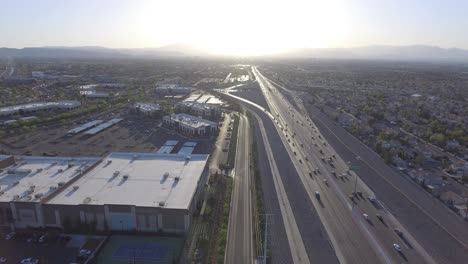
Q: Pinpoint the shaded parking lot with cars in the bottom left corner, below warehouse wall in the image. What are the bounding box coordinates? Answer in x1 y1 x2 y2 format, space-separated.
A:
0 231 102 264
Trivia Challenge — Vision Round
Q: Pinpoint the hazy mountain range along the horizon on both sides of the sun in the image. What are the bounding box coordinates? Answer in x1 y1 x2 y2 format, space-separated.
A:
0 44 468 62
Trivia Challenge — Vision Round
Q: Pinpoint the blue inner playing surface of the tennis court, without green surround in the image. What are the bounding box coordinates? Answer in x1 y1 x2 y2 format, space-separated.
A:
112 243 169 260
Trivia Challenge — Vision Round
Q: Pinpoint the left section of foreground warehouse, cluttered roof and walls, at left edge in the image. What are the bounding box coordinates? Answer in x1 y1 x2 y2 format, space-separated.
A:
0 156 99 228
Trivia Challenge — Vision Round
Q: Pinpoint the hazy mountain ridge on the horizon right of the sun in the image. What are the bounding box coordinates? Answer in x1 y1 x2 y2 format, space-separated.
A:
277 45 468 63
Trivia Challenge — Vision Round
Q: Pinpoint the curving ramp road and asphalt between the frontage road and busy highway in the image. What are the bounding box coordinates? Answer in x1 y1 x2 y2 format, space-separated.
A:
225 86 338 263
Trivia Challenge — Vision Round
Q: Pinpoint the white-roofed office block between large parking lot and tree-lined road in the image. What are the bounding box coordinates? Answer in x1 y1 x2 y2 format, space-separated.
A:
163 114 218 137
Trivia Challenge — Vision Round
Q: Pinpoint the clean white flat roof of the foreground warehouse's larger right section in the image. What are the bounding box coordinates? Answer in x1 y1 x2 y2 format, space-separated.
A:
49 153 209 209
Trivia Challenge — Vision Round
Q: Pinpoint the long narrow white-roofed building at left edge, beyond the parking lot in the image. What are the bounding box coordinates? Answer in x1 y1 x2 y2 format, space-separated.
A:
0 101 81 116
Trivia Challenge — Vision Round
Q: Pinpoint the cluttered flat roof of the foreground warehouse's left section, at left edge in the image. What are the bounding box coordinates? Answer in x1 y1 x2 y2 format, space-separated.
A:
0 156 99 202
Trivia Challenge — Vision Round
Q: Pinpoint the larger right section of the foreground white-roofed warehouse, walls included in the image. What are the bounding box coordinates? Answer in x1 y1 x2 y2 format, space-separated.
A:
43 153 208 233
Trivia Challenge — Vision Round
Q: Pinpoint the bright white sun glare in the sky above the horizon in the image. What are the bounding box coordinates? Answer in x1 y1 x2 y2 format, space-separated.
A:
133 0 351 56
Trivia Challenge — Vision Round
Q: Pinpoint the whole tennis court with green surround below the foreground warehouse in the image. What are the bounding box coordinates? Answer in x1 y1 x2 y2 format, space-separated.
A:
98 236 184 264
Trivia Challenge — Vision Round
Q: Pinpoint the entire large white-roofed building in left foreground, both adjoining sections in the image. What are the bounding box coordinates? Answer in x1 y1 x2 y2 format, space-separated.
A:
0 153 209 233
